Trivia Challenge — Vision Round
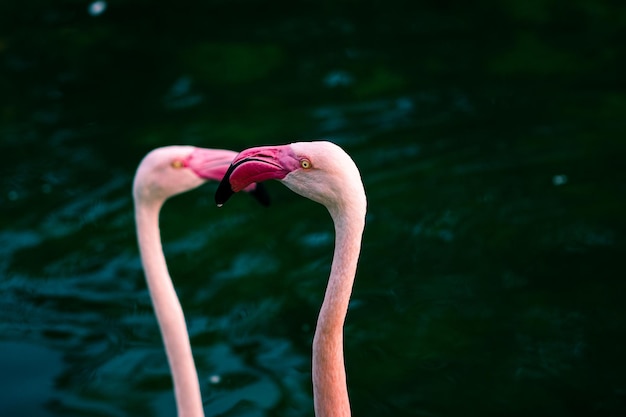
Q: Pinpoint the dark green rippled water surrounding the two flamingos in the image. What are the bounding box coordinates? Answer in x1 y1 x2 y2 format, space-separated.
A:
0 0 626 417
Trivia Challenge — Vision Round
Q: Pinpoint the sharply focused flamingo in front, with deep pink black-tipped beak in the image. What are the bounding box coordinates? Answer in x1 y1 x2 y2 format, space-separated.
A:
215 141 367 417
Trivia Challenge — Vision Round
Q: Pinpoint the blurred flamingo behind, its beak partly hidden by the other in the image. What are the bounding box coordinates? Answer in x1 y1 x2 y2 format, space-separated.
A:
133 146 268 417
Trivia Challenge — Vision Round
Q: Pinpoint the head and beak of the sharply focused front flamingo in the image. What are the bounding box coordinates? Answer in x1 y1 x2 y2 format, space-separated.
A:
215 141 365 214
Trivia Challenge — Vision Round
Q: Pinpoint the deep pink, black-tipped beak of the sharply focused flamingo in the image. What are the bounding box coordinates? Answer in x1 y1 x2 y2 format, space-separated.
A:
215 145 299 206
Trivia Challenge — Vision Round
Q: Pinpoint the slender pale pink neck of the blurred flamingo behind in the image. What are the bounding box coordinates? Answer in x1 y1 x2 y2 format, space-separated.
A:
135 202 204 417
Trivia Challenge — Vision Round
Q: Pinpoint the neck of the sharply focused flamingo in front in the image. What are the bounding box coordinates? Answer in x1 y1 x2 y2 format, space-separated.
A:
313 205 365 417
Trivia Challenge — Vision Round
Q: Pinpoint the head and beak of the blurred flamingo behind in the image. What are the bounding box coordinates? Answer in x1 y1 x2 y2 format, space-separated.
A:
133 146 269 205
